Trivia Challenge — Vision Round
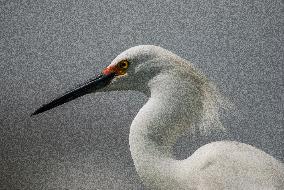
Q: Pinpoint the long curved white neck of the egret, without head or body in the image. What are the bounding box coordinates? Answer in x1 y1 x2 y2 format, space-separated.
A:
129 69 224 189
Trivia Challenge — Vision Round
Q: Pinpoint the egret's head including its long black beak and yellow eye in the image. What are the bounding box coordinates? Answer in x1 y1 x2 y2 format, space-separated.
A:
32 45 178 115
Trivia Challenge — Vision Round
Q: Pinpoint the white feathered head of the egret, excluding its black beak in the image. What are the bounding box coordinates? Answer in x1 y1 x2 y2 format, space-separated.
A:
98 45 186 94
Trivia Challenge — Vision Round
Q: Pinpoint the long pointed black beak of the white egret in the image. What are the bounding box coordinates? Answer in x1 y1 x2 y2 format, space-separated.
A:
31 73 115 116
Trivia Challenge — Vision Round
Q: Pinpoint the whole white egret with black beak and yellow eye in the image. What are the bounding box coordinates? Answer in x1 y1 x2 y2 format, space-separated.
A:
32 45 284 190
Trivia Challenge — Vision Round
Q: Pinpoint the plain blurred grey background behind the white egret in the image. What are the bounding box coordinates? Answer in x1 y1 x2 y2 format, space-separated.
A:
0 0 284 189
